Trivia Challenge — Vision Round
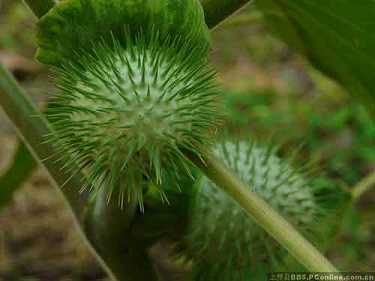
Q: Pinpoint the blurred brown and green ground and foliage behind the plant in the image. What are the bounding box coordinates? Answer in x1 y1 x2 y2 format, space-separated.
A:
0 0 375 281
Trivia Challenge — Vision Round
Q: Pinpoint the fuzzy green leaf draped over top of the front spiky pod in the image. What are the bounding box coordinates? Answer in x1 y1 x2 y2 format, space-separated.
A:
36 0 209 65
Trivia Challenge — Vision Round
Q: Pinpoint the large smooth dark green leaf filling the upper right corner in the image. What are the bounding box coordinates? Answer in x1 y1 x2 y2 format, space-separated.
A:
257 0 375 114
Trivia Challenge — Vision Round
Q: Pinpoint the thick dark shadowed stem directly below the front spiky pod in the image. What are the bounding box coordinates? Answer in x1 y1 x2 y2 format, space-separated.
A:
85 188 158 281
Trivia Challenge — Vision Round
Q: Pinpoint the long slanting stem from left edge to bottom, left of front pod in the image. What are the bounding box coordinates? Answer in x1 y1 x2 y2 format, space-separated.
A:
0 59 133 279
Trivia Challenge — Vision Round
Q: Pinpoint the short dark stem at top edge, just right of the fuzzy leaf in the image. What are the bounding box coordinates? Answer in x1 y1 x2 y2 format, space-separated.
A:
201 0 250 28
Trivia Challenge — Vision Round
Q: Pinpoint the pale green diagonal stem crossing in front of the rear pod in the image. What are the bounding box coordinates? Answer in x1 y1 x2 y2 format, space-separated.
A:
187 149 337 272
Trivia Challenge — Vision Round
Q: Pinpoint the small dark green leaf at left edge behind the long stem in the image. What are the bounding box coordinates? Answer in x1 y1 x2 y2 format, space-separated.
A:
0 143 37 210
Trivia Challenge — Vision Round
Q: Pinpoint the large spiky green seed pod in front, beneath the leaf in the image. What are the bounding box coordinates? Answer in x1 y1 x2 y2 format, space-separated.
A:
48 31 217 207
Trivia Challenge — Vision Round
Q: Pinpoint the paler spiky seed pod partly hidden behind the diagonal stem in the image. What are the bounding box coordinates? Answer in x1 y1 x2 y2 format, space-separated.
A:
188 142 321 281
